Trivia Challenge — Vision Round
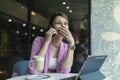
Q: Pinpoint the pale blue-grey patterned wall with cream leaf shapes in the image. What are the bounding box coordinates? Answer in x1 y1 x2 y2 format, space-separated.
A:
91 0 120 80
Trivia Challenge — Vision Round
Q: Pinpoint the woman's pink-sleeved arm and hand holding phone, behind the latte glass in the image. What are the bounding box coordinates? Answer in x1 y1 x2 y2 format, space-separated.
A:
29 28 56 74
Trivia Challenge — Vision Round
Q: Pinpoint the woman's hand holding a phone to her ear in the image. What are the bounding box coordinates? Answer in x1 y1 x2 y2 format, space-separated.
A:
45 27 57 43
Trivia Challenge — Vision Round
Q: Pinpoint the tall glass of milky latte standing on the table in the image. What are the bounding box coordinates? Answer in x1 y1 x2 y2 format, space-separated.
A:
34 55 44 72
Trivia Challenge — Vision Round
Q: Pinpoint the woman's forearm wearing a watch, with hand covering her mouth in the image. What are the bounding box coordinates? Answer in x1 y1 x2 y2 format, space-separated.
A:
60 27 75 68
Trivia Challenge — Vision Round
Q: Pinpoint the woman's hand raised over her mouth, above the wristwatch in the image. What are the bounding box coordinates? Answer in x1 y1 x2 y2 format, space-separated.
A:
59 27 75 45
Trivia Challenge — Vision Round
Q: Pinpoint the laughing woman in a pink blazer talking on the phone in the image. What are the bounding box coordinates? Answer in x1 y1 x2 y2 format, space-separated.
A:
27 12 75 74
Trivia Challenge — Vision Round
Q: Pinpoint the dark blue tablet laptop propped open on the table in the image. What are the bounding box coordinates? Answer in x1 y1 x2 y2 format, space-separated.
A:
61 55 107 80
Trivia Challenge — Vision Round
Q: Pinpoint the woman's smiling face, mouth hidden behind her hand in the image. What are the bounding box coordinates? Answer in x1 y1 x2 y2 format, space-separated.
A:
53 16 69 35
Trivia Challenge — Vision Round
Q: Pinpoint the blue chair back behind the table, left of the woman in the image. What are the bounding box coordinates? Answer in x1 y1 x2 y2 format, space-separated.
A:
12 60 29 77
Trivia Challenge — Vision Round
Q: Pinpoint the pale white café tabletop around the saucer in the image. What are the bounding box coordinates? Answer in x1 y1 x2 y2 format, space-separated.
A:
6 73 78 80
